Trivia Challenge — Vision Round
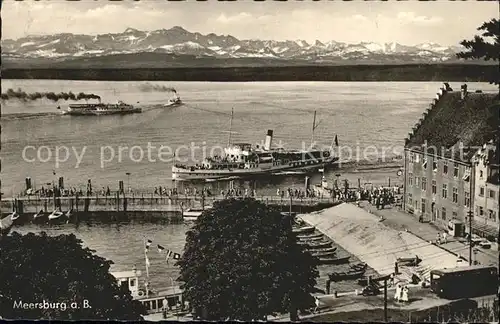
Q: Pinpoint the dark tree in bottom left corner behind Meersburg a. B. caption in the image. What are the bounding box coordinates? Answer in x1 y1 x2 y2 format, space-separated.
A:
0 232 145 320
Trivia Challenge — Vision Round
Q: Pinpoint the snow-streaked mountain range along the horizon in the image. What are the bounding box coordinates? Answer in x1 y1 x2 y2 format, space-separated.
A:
1 26 461 65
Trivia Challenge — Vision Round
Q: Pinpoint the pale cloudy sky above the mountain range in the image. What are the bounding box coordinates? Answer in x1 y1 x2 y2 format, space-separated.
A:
1 0 499 46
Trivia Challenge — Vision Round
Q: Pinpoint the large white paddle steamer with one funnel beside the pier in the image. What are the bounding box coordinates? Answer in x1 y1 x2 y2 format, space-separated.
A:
172 109 338 181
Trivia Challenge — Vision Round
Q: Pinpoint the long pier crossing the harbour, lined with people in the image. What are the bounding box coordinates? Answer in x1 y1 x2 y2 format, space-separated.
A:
0 194 335 222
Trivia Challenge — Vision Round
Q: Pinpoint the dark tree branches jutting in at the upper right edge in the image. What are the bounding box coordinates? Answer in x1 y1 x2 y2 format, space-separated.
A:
457 18 500 84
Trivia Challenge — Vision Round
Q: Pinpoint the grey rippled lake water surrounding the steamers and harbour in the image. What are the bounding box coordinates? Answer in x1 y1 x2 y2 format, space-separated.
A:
1 80 495 290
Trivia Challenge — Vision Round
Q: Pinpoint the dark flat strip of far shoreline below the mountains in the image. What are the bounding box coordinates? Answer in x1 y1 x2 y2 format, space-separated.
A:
2 64 498 82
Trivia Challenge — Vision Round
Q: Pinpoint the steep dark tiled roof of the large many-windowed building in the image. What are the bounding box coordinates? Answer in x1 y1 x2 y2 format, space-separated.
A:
406 91 500 162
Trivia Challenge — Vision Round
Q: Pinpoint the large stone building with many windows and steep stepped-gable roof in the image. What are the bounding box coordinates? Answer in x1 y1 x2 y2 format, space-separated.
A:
403 83 500 234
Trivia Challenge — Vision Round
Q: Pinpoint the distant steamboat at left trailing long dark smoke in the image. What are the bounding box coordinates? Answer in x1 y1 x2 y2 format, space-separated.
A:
63 100 142 116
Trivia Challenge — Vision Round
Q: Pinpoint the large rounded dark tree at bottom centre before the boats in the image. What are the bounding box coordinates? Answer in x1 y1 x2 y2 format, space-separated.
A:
178 198 318 321
